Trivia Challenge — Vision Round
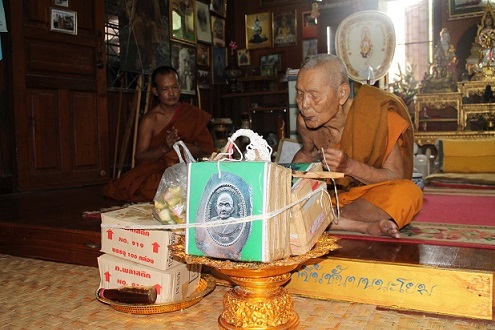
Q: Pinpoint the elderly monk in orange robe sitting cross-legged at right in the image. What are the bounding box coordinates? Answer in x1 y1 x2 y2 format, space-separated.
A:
293 54 423 238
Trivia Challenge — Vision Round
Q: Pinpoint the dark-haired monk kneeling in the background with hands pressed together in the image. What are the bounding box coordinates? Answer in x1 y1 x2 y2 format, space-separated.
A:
103 66 214 202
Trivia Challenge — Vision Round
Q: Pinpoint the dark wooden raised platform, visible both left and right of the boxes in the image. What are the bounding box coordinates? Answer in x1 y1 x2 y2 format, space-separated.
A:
0 186 495 322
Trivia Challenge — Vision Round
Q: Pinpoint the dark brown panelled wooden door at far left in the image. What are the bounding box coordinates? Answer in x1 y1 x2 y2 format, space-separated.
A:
10 0 108 190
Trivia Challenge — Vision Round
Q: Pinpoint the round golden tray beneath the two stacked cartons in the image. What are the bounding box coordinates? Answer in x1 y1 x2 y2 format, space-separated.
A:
96 275 216 315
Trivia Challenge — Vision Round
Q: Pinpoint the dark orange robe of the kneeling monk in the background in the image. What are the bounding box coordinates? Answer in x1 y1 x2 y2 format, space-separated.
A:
103 103 215 202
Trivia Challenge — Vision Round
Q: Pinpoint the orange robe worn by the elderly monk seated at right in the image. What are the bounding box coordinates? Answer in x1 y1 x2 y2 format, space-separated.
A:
339 85 423 229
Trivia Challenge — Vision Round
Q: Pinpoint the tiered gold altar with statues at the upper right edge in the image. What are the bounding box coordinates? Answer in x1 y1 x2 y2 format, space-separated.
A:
414 2 495 146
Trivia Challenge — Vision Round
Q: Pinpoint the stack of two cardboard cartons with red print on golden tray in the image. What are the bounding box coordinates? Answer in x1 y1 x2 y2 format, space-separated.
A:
98 204 201 303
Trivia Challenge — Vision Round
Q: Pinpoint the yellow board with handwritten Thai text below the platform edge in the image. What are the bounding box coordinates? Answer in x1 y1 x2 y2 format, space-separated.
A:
286 258 494 320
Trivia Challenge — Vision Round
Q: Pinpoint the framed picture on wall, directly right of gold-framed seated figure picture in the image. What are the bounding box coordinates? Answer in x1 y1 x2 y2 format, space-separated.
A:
272 10 297 47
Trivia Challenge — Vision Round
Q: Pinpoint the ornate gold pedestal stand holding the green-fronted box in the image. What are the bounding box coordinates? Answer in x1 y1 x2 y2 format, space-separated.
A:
170 234 340 329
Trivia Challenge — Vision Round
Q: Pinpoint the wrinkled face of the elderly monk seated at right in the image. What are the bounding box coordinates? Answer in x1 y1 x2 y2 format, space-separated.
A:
296 68 339 129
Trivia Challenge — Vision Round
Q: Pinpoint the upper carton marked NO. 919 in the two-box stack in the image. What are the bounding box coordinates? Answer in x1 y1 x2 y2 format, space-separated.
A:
101 204 180 270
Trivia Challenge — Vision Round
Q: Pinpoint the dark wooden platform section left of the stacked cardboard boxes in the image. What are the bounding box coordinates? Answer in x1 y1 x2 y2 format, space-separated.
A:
0 186 123 266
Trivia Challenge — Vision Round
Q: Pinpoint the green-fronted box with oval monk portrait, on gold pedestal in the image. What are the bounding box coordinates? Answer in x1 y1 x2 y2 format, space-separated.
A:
186 161 292 262
